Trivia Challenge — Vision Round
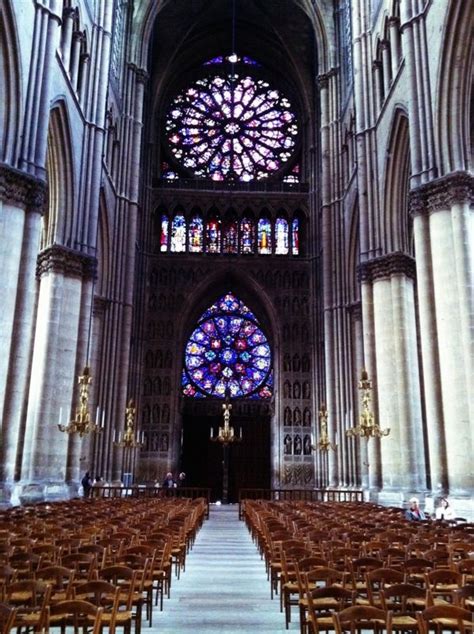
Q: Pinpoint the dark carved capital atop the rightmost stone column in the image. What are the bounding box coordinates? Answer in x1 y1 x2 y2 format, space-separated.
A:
410 172 474 216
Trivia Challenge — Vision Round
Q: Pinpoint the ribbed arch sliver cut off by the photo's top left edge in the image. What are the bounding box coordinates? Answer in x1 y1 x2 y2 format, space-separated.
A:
0 0 22 165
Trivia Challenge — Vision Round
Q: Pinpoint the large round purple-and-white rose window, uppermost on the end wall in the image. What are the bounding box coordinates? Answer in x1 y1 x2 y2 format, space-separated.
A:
166 63 298 181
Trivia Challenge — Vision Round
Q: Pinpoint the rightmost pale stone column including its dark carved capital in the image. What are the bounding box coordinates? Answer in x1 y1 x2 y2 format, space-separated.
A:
412 172 474 497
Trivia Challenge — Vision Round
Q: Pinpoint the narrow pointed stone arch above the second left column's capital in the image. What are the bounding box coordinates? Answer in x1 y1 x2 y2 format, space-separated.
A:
41 101 75 249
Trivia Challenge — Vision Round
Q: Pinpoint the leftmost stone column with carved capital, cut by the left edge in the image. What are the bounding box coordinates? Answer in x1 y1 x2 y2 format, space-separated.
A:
0 165 45 488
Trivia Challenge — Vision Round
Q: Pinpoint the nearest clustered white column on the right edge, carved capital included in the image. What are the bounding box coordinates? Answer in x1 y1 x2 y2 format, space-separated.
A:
411 172 474 497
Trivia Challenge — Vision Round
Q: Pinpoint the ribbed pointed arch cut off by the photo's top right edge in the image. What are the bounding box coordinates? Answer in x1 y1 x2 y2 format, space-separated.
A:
435 0 474 176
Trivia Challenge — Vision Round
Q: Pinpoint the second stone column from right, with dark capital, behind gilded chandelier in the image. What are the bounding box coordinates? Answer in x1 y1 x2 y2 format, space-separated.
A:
361 253 426 503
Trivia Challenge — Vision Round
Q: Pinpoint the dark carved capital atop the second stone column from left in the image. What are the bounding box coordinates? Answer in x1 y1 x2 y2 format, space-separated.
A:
36 244 97 279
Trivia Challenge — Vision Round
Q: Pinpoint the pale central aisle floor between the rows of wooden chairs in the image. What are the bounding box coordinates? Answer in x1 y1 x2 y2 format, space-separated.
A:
156 505 299 634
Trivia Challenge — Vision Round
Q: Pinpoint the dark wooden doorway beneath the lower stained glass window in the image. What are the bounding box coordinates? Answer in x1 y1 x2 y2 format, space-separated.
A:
182 415 270 502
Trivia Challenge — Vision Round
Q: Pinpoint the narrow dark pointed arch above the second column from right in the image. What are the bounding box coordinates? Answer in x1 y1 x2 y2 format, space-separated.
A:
381 108 411 253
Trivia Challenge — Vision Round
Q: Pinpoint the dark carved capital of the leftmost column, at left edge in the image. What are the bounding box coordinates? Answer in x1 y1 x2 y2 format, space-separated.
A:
0 163 46 214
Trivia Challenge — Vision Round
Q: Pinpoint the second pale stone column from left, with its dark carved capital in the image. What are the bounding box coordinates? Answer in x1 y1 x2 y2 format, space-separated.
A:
20 245 95 501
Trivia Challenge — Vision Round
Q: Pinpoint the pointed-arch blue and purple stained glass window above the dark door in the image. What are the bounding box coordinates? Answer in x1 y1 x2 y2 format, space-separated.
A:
182 292 273 398
